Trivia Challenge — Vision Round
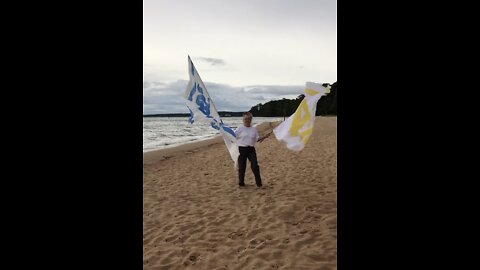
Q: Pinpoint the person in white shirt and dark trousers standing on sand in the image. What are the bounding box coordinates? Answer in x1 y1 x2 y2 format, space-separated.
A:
235 112 270 187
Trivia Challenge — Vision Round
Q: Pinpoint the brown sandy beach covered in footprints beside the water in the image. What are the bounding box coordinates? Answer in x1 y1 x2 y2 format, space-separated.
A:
143 117 337 270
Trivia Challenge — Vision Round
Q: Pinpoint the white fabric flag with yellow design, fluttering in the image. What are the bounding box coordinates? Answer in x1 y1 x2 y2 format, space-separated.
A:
273 82 330 151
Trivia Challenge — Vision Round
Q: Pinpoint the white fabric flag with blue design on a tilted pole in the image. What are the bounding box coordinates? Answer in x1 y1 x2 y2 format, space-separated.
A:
183 56 240 168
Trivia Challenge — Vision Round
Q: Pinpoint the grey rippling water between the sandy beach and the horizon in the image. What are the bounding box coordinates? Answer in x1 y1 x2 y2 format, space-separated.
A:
143 117 283 152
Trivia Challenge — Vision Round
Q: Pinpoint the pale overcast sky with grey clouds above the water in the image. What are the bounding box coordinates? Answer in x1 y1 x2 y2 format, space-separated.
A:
143 0 337 114
